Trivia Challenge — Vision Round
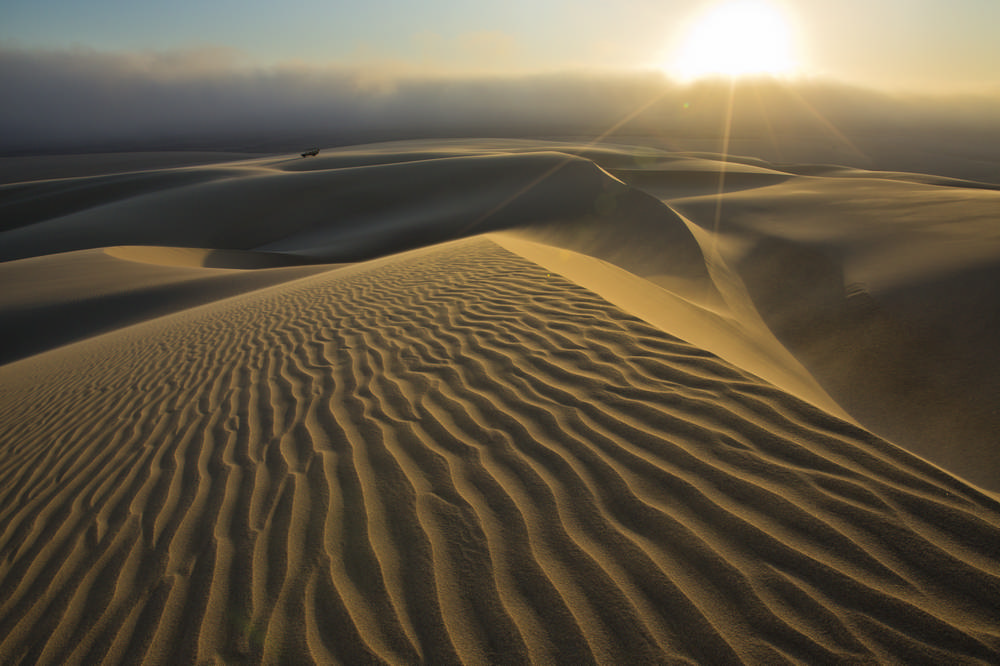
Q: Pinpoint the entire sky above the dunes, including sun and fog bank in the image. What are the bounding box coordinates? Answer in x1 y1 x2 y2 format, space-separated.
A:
0 0 1000 154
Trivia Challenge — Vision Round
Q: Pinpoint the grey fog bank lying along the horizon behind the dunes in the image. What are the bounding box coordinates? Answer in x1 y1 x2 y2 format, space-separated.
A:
0 48 1000 179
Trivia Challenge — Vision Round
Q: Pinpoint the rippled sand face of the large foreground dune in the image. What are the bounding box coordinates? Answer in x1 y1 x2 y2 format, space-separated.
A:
0 239 1000 664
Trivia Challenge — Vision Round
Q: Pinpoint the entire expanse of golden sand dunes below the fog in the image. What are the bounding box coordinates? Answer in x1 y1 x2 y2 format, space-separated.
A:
0 141 1000 664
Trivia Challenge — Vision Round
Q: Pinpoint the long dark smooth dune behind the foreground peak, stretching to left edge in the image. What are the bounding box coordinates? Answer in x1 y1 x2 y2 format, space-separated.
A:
0 150 625 261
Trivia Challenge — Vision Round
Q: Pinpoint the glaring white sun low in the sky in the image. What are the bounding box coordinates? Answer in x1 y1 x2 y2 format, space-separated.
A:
664 0 796 81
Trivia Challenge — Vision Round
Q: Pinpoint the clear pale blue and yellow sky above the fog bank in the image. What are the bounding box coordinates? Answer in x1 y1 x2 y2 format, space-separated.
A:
0 0 1000 92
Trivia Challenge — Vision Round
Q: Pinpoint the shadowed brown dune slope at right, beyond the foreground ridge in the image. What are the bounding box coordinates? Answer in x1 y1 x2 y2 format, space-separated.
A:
670 174 1000 491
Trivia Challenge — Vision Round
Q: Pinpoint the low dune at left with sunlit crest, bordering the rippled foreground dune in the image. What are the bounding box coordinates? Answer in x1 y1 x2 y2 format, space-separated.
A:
0 247 334 363
